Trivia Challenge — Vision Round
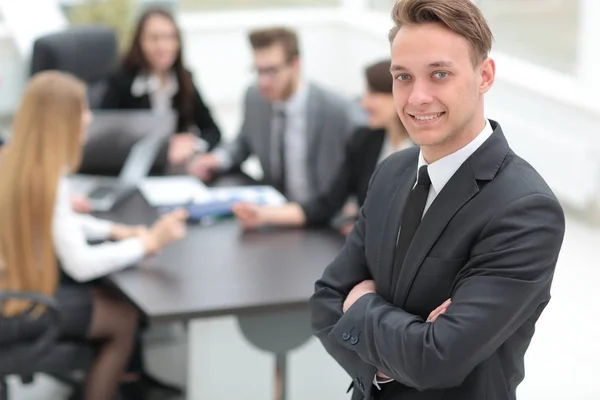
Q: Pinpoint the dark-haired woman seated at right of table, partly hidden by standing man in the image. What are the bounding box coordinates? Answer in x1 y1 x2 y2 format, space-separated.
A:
233 60 412 234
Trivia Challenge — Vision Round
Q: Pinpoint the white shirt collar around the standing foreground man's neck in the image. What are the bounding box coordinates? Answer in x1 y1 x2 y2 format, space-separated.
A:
417 119 493 193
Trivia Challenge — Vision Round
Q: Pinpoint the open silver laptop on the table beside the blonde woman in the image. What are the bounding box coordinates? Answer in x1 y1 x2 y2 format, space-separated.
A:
70 114 171 212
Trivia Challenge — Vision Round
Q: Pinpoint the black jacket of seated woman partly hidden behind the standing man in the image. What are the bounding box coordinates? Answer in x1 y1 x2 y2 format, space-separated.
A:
301 127 385 225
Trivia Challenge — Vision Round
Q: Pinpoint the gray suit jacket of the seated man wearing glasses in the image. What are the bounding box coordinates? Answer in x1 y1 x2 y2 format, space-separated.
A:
223 83 354 193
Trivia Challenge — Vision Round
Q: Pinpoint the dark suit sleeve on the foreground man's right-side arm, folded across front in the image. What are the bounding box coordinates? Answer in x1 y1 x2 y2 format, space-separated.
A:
320 194 565 390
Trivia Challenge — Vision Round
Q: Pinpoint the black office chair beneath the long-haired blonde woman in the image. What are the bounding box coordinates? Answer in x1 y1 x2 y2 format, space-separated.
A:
0 292 93 400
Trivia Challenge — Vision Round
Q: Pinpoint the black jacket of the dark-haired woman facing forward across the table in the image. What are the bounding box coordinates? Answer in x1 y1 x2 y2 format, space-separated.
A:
100 69 221 149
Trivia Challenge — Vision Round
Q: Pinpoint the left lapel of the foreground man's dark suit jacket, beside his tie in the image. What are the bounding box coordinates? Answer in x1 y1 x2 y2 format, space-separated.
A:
377 160 417 300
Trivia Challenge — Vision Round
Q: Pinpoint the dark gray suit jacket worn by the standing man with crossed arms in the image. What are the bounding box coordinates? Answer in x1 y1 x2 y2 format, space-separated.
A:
310 121 565 400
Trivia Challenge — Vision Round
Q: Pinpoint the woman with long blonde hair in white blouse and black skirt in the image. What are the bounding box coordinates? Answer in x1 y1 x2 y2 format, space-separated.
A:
0 71 186 400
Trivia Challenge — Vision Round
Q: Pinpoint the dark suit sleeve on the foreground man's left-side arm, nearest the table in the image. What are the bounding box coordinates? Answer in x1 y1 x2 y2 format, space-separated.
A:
310 162 390 393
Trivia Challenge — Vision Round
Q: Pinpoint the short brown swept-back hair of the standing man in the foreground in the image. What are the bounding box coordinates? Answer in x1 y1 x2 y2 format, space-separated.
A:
389 0 494 65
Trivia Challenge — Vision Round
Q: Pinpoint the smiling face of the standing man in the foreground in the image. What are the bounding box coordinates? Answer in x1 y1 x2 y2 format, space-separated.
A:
391 23 495 162
